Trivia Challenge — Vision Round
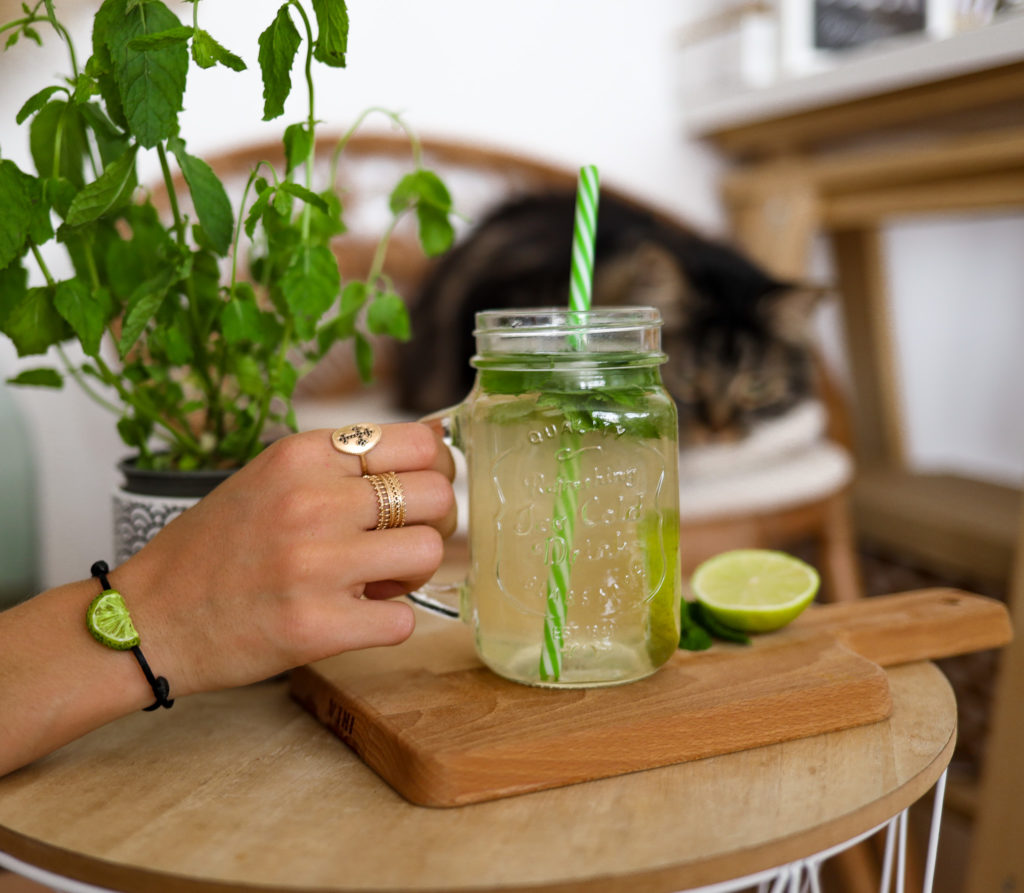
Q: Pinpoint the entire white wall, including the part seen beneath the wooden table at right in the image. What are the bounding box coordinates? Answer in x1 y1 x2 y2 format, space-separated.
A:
0 0 1024 584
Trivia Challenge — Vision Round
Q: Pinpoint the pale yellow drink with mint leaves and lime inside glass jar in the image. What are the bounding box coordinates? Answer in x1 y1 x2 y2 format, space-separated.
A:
454 311 681 687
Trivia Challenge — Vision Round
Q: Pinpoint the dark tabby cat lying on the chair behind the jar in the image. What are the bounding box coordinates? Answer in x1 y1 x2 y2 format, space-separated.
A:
398 194 817 442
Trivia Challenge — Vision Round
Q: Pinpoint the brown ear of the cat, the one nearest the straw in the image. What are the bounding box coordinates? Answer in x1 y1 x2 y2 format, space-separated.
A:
595 242 694 330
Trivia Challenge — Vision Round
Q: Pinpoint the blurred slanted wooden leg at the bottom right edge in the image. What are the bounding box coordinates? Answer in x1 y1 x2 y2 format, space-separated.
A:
967 505 1024 893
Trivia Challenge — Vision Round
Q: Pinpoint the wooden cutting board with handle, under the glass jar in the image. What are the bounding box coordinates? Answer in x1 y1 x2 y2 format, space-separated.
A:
291 589 1012 806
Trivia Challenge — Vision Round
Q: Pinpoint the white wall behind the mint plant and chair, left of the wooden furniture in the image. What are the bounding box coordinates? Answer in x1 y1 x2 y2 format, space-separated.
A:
0 0 719 584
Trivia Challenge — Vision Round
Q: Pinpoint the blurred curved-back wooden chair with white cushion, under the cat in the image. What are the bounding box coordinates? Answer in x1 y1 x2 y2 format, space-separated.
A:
195 134 860 600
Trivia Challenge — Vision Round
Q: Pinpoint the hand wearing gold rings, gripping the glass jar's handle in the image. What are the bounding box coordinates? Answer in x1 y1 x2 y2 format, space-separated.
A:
111 424 455 697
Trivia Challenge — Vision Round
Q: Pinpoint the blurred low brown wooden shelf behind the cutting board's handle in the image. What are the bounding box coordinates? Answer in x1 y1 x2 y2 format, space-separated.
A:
852 468 1021 583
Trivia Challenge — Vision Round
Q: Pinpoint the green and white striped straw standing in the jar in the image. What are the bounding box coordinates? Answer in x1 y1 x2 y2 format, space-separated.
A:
540 165 598 682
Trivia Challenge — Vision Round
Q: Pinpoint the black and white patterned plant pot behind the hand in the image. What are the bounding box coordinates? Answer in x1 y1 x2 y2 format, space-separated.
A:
113 459 231 564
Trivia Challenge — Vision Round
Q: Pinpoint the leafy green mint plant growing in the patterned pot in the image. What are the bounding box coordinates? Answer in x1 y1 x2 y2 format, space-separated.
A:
0 0 453 469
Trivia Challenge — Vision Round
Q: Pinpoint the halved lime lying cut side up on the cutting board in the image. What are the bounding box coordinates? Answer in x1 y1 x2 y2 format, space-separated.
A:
690 549 820 633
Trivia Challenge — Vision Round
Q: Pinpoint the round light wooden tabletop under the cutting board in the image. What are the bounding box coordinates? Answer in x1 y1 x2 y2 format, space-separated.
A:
0 647 956 893
